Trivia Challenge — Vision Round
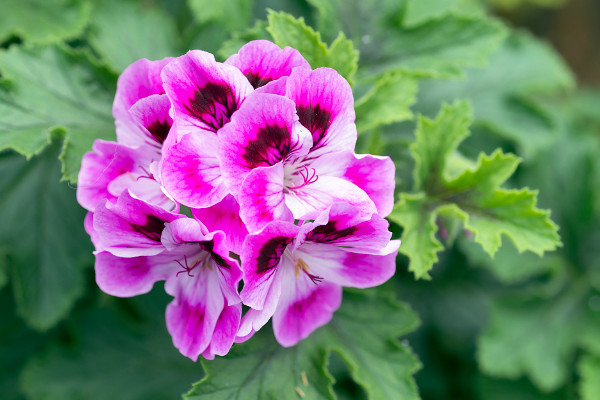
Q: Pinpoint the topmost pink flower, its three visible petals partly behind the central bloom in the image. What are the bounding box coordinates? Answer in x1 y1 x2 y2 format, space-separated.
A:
162 40 309 208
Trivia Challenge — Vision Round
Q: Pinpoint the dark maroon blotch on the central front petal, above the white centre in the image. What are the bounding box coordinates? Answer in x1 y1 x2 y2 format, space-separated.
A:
242 125 294 169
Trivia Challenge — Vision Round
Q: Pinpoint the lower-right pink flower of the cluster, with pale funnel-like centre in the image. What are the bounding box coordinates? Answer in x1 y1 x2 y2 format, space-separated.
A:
238 203 400 347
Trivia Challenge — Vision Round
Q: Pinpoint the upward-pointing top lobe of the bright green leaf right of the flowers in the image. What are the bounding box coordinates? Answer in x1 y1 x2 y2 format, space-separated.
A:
410 102 471 191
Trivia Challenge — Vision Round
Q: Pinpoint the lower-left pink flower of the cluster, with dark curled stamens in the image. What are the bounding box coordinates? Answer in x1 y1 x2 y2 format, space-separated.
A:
93 192 242 360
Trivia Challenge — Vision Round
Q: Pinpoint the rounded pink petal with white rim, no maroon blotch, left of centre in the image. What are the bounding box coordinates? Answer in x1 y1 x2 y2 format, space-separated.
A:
161 133 228 208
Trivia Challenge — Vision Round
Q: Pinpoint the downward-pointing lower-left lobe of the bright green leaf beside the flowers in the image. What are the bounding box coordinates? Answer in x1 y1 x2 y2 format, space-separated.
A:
388 194 444 279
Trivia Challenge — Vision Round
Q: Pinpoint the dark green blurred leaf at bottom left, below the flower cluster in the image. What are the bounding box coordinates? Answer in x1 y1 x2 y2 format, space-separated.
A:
20 289 202 400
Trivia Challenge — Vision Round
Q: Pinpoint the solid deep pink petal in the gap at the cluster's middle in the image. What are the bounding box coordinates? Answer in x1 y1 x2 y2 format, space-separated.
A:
192 195 248 254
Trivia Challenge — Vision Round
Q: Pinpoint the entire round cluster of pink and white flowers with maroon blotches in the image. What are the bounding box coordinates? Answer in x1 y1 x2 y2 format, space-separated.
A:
77 41 399 360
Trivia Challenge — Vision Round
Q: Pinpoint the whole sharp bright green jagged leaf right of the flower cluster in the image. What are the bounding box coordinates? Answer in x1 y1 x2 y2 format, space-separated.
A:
390 102 560 278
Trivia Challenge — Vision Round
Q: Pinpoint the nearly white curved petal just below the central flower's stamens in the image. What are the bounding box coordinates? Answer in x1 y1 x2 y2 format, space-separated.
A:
285 176 377 219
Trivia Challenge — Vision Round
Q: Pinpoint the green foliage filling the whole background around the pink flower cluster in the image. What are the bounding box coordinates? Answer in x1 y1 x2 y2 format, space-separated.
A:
0 0 600 400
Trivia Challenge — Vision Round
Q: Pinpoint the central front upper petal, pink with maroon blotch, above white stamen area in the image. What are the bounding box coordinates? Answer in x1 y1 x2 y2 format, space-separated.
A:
219 93 311 195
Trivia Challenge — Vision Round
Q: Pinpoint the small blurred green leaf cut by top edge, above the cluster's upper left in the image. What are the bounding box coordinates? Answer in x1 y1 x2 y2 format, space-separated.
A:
188 0 252 30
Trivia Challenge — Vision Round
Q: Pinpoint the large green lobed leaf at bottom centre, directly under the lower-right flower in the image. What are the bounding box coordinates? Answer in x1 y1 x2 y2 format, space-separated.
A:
185 291 419 400
